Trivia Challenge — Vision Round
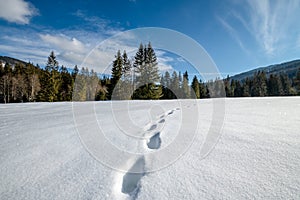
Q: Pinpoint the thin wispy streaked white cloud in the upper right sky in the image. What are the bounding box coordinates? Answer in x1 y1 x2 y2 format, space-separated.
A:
219 0 300 55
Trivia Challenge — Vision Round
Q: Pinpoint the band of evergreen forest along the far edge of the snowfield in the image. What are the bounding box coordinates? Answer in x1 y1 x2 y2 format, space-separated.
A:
0 43 300 103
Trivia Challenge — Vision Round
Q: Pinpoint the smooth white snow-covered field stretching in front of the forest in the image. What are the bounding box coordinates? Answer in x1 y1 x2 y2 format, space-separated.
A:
0 97 300 199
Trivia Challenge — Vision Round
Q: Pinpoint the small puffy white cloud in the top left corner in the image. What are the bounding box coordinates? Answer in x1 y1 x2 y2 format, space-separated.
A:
0 0 38 24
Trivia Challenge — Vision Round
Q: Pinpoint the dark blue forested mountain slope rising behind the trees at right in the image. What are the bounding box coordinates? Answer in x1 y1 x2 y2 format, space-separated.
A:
230 60 300 81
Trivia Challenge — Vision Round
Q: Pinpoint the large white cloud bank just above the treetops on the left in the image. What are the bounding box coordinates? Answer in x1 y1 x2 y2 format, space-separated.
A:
39 30 137 73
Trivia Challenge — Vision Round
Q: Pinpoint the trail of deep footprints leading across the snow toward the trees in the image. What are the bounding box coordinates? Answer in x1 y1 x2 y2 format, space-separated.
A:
122 108 180 199
